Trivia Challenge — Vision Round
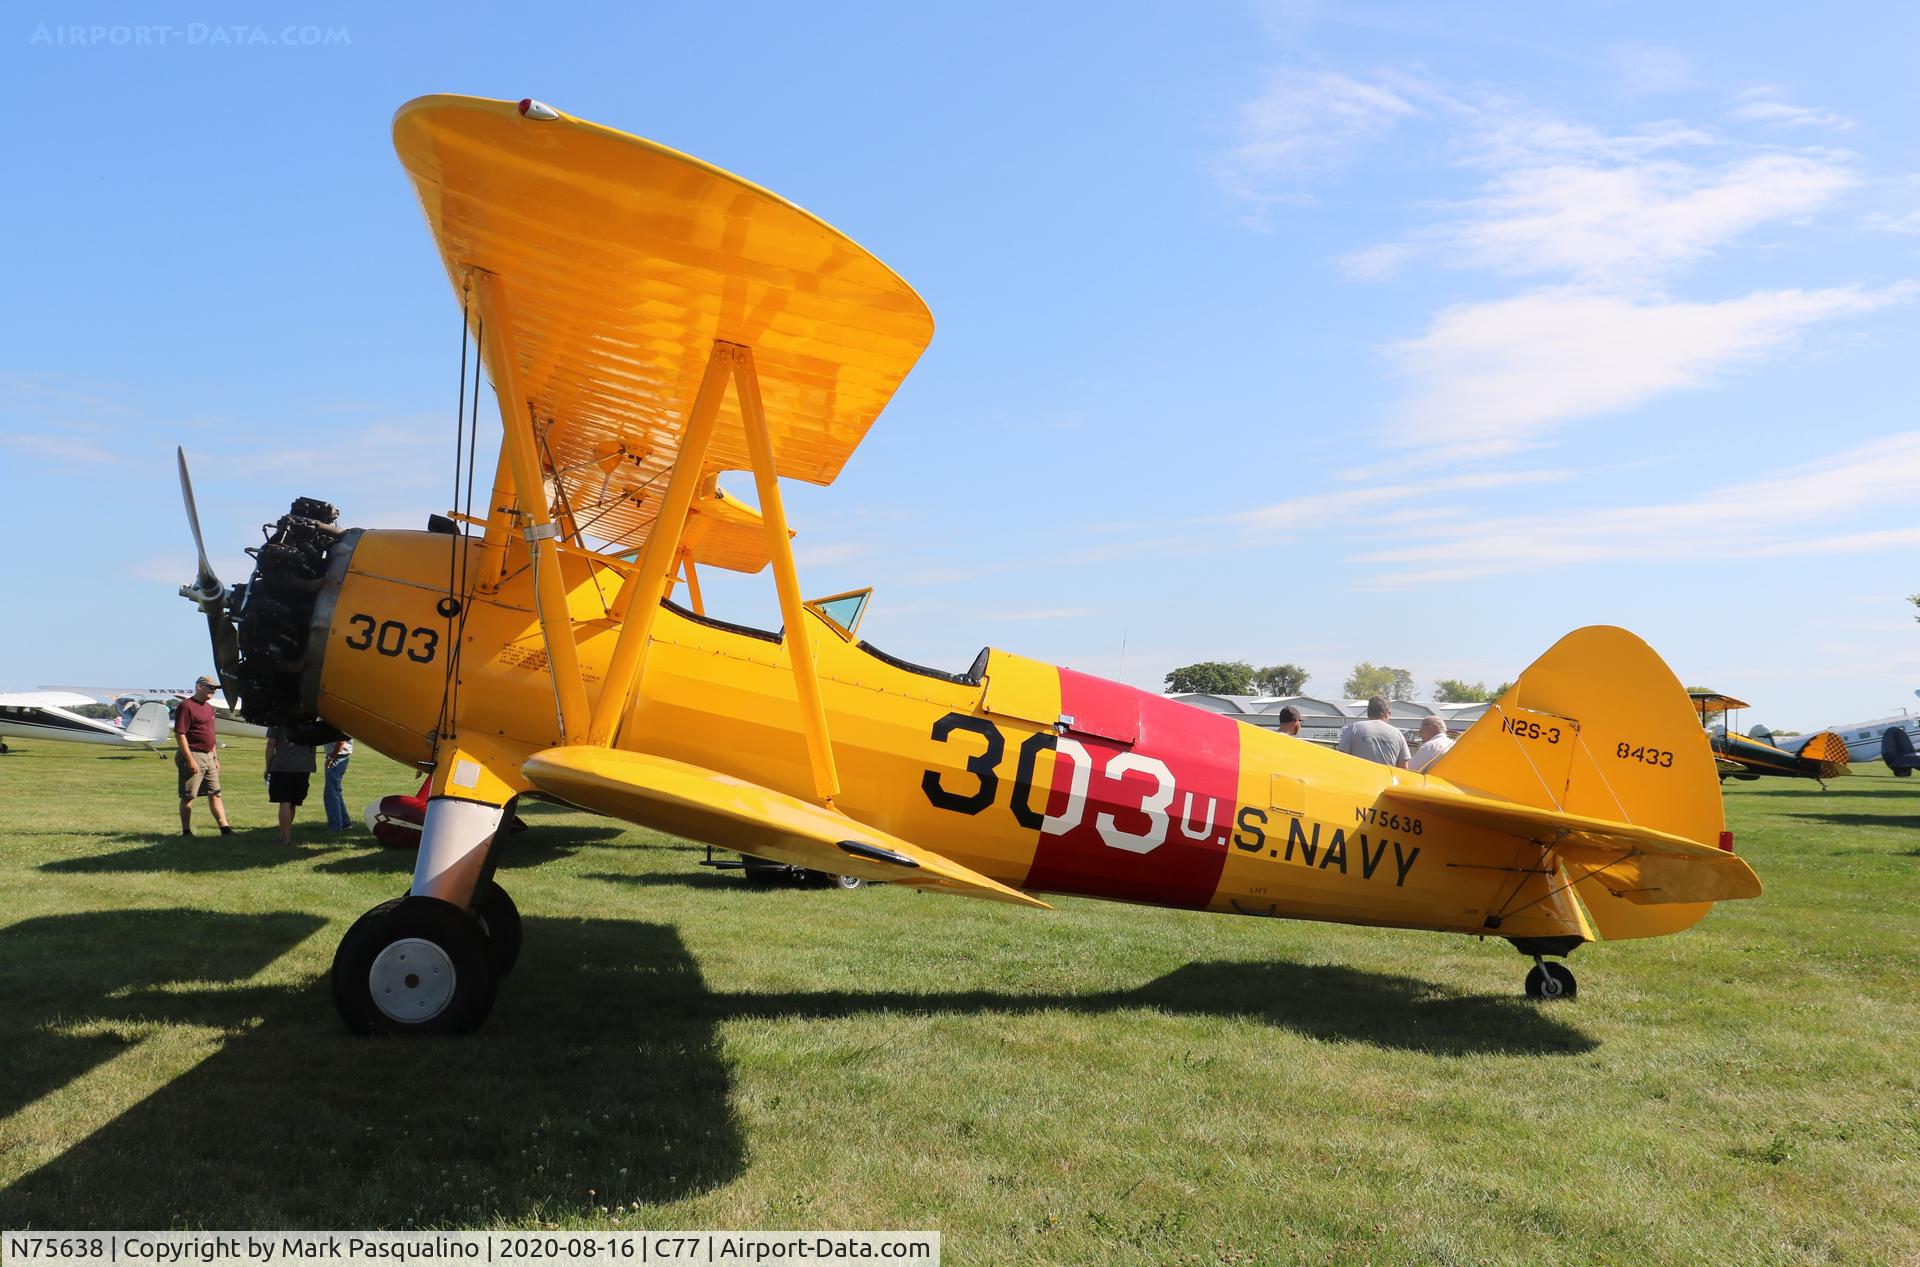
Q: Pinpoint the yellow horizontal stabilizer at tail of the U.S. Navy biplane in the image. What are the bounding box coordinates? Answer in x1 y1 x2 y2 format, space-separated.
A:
1384 787 1761 906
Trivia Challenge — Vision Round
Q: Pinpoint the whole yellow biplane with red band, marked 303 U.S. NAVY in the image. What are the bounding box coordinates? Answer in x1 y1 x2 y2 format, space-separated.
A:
182 96 1759 1035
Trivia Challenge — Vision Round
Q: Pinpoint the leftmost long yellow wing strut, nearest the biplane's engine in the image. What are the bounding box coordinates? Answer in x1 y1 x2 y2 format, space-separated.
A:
474 269 589 745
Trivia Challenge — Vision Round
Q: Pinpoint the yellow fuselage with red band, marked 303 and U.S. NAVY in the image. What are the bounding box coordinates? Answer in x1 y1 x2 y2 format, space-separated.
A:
303 532 1586 937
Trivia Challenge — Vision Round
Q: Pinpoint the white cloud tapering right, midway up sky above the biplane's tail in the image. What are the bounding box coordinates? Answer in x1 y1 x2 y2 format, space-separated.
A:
1386 284 1914 461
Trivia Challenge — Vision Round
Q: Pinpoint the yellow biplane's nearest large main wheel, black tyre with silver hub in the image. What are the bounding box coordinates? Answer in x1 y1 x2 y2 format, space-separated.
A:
334 896 497 1035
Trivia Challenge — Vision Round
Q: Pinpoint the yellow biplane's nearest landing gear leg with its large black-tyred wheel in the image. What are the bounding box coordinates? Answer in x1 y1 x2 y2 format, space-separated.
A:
332 797 520 1035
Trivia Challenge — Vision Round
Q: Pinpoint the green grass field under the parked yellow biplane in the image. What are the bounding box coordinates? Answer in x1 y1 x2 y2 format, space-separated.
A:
0 741 1920 1265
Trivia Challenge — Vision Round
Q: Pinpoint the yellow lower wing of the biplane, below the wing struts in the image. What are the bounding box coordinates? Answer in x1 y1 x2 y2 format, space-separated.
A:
520 747 1050 910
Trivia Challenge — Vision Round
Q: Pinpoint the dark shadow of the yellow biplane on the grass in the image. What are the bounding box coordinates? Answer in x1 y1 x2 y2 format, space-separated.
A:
0 910 1596 1229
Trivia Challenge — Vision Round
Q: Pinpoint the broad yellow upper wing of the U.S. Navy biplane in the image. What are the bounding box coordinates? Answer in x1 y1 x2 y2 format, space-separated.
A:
394 96 933 566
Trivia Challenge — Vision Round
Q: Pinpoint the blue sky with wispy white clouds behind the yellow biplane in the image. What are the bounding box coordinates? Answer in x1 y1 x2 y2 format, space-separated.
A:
0 4 1920 728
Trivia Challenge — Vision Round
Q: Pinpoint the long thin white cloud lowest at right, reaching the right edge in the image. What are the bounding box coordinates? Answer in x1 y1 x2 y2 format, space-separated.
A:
1361 432 1920 587
